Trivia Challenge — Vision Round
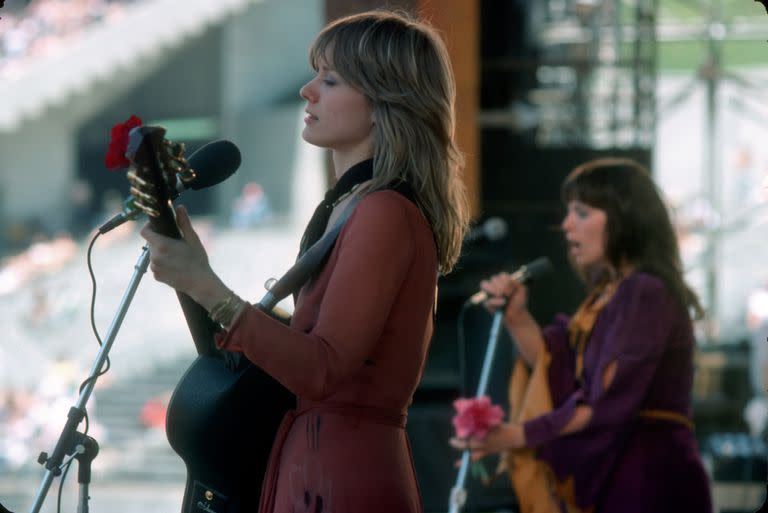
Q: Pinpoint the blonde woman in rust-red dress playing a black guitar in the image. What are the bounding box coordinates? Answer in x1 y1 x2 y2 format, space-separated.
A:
142 11 467 513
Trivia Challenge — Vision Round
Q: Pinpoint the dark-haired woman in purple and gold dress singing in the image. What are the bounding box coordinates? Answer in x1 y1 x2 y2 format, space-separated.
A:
451 159 712 513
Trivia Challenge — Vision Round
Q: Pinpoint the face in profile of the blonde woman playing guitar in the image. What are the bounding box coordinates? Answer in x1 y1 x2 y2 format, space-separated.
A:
299 55 373 157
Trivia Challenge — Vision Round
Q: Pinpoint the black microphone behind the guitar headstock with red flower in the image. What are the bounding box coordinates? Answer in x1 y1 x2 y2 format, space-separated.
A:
99 139 241 234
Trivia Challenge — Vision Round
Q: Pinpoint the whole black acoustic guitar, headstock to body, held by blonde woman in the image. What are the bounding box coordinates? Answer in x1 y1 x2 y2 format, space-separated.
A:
126 126 296 513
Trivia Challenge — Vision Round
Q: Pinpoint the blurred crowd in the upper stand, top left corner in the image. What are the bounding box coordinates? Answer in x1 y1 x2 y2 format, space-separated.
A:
0 0 141 75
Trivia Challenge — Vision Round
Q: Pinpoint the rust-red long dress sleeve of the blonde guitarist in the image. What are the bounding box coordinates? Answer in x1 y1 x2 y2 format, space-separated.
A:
213 192 414 400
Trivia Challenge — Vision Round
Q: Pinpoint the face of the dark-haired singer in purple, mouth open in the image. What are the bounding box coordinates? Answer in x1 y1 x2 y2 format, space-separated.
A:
561 200 607 268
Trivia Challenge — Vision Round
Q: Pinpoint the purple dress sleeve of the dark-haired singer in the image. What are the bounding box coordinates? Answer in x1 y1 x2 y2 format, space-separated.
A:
524 275 678 447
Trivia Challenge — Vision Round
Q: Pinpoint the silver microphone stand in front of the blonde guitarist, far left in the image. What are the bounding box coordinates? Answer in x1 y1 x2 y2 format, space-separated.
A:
30 246 149 513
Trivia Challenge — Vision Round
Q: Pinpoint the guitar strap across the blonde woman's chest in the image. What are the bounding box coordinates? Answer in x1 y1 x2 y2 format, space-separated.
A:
258 196 360 312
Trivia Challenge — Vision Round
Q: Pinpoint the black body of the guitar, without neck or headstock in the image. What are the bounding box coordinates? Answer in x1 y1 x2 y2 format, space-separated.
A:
166 355 296 513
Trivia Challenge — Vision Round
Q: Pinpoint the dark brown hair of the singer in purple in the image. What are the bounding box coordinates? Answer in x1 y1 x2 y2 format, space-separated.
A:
560 158 703 317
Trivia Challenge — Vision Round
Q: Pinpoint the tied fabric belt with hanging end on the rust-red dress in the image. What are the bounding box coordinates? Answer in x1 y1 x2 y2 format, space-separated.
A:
259 401 408 513
